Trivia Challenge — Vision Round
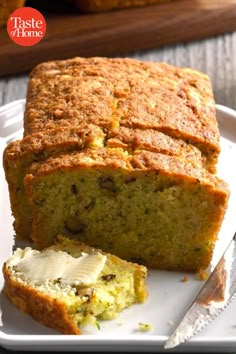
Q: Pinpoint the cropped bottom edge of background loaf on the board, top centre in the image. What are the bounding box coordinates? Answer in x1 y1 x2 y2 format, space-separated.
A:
73 0 179 12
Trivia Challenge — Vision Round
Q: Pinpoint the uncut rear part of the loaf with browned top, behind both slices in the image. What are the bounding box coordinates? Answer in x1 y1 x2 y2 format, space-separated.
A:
24 57 220 172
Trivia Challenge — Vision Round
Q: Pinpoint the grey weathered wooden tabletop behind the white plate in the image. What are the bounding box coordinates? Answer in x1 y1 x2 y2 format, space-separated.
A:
0 32 236 109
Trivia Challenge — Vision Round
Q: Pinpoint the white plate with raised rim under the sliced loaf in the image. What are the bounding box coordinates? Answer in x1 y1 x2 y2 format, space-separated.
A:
0 100 236 352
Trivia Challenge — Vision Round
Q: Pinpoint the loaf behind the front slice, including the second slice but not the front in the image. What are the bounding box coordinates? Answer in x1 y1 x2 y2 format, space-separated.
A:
4 58 220 243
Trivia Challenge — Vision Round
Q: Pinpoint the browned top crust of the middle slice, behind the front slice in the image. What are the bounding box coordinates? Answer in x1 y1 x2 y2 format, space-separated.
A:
3 124 202 165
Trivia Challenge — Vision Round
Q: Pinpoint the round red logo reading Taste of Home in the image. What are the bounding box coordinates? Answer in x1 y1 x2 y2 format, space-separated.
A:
7 7 46 46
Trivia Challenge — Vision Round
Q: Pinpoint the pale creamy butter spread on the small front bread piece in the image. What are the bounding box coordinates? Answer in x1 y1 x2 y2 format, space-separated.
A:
7 249 107 285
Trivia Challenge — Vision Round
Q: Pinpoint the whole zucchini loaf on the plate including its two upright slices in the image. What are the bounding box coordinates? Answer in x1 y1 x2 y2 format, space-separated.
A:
4 58 229 271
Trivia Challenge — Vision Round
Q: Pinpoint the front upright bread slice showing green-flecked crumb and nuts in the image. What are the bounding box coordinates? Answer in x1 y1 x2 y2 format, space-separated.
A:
25 147 229 271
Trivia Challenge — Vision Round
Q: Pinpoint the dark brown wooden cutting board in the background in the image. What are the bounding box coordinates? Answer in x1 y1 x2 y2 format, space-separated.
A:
0 0 236 76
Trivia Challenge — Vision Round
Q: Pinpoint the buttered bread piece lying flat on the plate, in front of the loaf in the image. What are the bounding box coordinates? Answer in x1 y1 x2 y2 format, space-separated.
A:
3 236 147 334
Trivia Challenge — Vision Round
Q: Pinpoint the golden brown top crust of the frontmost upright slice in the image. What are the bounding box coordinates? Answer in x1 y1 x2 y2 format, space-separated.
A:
25 148 228 194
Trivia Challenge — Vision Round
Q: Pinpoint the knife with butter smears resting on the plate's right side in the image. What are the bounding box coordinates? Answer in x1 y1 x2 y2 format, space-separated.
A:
164 233 236 349
